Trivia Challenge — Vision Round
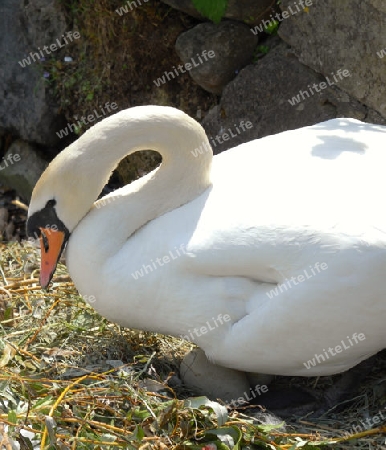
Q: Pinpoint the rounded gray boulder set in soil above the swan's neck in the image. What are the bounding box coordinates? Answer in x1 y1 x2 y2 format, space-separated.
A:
176 21 258 94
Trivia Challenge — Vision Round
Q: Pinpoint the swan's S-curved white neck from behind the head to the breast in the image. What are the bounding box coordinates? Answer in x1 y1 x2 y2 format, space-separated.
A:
57 107 212 327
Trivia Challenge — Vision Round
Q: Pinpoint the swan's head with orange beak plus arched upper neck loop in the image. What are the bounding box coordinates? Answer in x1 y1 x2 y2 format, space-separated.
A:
27 106 212 288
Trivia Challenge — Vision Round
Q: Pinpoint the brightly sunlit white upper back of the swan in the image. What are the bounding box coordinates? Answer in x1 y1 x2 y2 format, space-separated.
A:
212 119 386 228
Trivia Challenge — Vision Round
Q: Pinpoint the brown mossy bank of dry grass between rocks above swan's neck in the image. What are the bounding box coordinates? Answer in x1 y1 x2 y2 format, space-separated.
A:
49 0 217 127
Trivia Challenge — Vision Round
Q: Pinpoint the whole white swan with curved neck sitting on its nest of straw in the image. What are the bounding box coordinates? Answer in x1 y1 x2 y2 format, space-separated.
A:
28 106 386 376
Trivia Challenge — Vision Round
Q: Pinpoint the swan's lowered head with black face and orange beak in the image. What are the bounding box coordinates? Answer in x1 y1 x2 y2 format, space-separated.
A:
27 134 105 288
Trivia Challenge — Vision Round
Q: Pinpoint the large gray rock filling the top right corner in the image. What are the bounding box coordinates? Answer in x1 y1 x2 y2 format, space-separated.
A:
279 0 386 118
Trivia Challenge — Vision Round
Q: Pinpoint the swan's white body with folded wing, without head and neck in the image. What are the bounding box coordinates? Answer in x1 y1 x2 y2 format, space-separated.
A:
65 119 386 375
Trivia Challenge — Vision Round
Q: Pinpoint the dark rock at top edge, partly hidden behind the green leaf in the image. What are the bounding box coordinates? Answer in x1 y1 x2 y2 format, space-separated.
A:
162 0 278 25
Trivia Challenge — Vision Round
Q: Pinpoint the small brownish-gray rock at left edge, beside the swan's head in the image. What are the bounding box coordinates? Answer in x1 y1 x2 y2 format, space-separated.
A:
0 139 47 200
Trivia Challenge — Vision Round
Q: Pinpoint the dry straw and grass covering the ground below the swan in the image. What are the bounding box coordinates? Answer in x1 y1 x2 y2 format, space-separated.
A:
0 242 386 450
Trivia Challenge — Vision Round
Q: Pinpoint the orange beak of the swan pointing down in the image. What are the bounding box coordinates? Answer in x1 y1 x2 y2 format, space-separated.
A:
40 228 65 289
